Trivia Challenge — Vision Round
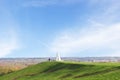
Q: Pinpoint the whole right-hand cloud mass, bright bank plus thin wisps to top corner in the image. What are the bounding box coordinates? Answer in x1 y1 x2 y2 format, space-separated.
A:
50 0 120 56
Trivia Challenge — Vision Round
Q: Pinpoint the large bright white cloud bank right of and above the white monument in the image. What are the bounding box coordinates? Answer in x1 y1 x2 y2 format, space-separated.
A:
50 23 120 56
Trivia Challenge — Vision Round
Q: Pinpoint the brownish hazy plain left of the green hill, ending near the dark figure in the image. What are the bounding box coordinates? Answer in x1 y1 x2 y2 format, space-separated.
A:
0 58 47 75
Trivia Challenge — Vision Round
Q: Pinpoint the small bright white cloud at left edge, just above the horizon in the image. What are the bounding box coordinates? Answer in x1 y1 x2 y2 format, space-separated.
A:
0 28 18 57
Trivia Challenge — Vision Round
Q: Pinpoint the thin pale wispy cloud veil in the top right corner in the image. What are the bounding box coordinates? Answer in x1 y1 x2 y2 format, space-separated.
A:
89 0 120 24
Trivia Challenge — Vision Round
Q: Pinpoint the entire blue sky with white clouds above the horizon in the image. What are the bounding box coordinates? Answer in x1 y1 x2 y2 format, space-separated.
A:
0 0 120 57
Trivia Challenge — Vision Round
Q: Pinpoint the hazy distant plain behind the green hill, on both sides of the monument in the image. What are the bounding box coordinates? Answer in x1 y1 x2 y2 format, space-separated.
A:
0 57 120 77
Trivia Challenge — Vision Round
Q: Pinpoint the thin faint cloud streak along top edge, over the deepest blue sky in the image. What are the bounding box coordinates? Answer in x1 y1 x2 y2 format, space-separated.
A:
23 0 82 7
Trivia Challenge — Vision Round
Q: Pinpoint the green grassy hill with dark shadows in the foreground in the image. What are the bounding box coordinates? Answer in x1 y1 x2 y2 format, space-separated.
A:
0 62 120 80
